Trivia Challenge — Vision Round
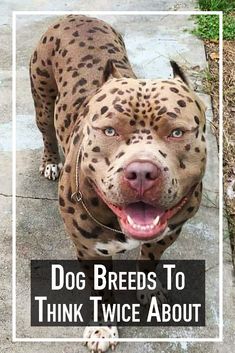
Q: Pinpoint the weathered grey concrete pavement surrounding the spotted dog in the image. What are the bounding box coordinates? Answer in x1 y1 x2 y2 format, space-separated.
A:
0 0 235 353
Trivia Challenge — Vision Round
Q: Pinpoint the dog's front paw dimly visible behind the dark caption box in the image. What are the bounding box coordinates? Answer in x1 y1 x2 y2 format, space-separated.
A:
136 278 168 305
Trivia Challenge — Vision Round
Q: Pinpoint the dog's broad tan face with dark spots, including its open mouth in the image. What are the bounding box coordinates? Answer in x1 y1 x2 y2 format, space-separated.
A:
80 73 206 240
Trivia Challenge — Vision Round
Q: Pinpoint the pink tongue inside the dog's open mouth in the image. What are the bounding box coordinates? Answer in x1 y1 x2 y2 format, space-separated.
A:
124 202 164 225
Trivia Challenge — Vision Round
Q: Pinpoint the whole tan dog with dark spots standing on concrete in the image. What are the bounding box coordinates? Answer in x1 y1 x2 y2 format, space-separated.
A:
30 15 206 352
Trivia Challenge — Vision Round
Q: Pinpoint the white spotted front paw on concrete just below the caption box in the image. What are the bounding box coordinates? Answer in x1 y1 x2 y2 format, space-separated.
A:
83 326 118 353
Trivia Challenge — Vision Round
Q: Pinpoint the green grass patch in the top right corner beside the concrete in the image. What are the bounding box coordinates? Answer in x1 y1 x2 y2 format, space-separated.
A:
193 0 235 40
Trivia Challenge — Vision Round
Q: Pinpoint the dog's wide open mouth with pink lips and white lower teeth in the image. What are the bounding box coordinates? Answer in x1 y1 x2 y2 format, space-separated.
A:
92 184 192 241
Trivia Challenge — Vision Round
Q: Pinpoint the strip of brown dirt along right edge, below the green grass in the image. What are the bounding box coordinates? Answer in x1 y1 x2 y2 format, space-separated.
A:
203 41 235 265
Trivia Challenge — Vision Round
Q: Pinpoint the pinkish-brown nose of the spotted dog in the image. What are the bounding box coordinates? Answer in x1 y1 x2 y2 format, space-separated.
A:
124 161 160 195
